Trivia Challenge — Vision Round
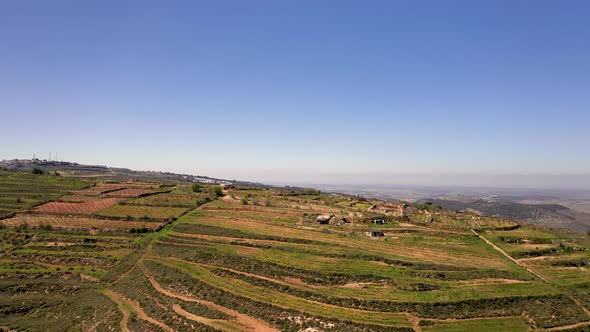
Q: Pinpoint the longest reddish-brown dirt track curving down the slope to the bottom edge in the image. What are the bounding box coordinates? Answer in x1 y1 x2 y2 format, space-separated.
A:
144 269 279 332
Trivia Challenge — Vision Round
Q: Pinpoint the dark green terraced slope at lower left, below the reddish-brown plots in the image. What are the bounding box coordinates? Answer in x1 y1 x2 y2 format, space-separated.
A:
0 224 140 331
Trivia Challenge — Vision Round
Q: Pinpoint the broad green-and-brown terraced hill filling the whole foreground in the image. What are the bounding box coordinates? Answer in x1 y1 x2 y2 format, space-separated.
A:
0 172 590 331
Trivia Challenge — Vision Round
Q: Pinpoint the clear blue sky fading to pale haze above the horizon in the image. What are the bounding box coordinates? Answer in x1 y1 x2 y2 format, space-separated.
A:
0 0 590 185
